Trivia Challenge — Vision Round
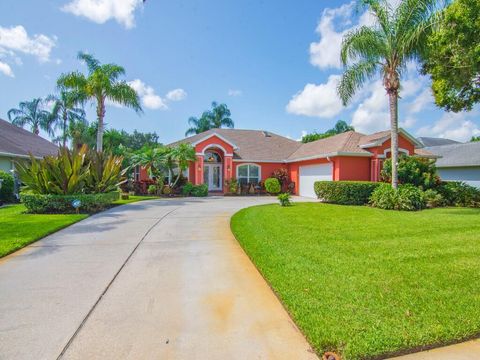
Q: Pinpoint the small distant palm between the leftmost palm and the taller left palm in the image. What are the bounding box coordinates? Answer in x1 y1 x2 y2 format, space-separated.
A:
46 86 87 147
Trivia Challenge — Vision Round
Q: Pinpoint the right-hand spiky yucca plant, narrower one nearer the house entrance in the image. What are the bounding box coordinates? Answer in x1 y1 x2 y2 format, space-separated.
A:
87 151 126 193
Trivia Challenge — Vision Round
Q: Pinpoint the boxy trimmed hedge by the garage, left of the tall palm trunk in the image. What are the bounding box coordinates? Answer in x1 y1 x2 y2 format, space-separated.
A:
314 181 380 205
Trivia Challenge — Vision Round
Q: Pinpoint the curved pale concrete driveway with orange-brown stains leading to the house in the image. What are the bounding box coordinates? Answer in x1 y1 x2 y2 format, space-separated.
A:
0 197 317 359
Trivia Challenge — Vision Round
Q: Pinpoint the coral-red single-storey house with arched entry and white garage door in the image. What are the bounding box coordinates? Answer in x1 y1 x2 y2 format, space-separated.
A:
162 129 432 197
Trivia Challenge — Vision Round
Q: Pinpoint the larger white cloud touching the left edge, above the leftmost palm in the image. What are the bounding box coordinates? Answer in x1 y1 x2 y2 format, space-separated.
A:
0 25 57 62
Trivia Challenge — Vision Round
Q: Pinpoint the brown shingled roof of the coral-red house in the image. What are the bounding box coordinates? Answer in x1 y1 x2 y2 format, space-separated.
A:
169 129 428 162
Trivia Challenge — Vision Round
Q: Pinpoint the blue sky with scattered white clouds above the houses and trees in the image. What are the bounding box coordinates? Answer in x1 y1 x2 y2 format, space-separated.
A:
0 0 480 143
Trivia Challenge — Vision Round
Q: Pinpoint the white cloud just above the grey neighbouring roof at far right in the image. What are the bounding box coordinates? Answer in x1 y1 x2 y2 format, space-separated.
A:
417 113 480 141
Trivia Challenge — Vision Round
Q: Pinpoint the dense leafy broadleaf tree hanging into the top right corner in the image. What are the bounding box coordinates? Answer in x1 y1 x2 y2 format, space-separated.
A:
422 0 480 112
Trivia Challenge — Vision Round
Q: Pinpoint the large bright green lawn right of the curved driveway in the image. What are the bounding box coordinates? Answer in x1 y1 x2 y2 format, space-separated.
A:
231 203 480 359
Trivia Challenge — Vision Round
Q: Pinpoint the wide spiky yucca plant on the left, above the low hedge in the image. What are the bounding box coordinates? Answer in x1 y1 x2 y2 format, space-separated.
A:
16 146 90 195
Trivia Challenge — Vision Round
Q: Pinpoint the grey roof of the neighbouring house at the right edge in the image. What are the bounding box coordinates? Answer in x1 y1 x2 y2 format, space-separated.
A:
426 142 480 168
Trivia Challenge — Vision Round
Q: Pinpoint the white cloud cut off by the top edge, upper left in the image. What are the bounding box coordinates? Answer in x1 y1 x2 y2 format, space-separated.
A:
62 0 143 29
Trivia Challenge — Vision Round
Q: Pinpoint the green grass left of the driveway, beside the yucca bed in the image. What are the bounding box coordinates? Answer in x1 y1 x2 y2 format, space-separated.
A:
0 196 156 258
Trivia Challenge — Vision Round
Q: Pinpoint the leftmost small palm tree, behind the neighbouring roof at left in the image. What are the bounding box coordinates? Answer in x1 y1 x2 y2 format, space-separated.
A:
7 98 55 136
